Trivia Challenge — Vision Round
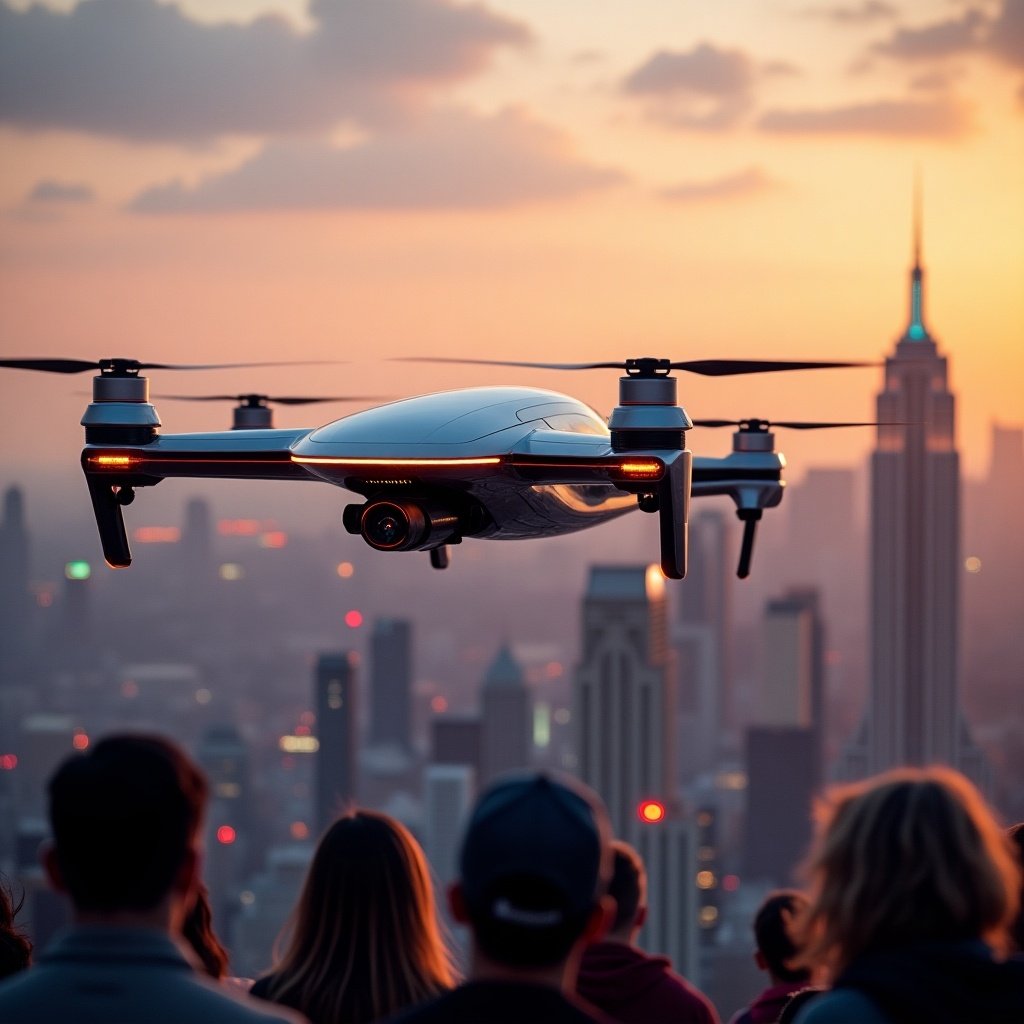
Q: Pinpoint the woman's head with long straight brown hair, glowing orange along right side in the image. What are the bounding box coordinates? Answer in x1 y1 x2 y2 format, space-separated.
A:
268 810 454 1024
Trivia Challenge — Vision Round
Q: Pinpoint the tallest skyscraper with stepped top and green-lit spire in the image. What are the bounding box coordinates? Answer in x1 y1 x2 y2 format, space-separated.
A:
841 205 987 785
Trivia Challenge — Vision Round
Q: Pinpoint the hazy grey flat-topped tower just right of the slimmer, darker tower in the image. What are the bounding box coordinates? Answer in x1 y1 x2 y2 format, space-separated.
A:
370 618 413 751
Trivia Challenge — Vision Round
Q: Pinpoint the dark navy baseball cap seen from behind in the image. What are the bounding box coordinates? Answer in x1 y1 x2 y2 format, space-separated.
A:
460 772 611 934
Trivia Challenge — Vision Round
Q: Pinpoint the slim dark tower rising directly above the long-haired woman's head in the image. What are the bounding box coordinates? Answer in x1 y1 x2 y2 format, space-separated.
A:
313 651 357 831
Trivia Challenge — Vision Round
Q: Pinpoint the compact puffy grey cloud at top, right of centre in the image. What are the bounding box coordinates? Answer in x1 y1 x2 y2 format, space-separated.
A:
622 43 757 130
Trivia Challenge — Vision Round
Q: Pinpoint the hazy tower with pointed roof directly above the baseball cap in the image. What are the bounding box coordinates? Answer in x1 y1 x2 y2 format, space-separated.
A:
480 644 532 784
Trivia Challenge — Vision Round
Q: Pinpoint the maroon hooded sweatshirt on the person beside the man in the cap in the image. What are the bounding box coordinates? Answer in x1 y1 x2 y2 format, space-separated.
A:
577 942 718 1024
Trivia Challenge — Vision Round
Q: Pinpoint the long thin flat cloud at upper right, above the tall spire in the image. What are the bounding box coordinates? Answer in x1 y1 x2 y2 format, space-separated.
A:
758 97 973 138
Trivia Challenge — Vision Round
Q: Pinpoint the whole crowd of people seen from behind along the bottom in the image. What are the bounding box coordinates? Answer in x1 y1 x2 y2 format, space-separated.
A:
0 735 1024 1024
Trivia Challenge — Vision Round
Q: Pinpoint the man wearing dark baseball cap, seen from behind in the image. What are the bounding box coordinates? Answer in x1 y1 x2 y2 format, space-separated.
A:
389 773 611 1024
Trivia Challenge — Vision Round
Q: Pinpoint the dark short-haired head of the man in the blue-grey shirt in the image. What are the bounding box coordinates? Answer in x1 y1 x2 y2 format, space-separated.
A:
46 735 207 916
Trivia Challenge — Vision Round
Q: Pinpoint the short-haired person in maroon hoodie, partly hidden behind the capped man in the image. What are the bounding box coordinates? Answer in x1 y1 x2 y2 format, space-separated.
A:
577 840 718 1024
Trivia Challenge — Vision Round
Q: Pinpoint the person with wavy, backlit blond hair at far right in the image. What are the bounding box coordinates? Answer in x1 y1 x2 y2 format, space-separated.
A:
796 767 1024 1024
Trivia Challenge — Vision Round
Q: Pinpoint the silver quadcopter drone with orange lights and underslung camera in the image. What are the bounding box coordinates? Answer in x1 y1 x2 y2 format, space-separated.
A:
0 356 877 580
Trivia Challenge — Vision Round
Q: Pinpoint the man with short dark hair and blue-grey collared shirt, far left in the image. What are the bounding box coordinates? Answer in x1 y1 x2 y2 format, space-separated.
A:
0 735 301 1024
